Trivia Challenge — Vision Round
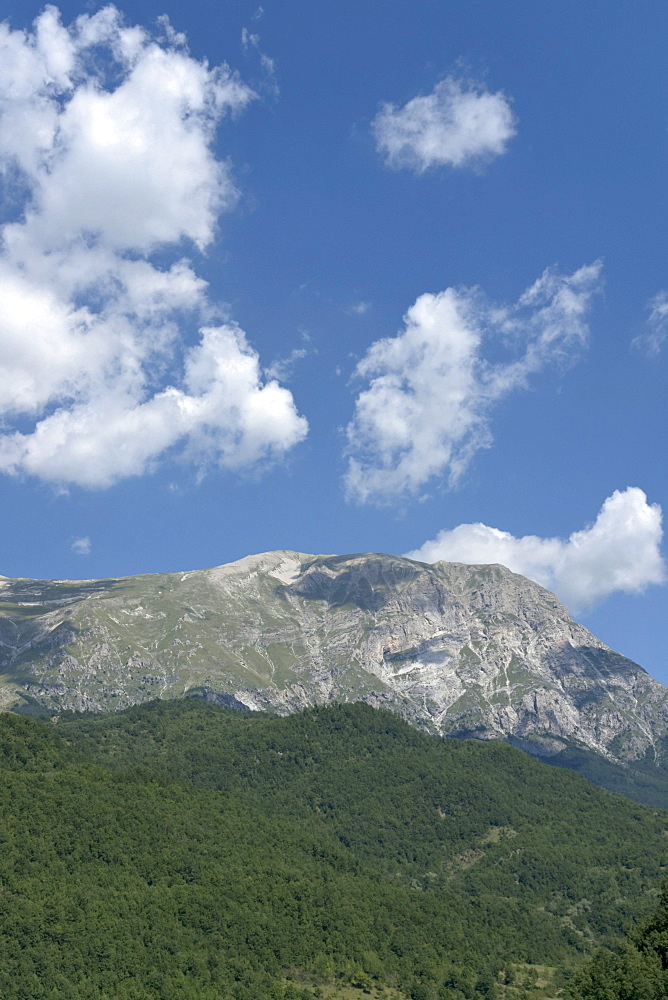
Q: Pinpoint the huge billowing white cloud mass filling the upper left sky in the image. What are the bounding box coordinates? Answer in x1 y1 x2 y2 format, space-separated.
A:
0 6 307 487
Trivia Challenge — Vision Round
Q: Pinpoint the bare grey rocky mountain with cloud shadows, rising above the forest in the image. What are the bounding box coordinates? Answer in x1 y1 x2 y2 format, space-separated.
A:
0 551 668 804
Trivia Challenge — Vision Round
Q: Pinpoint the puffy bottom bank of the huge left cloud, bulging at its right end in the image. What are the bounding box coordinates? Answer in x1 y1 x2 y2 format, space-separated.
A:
0 324 306 487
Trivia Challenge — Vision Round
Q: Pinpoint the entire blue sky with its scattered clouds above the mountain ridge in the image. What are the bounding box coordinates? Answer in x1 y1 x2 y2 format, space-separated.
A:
0 0 668 682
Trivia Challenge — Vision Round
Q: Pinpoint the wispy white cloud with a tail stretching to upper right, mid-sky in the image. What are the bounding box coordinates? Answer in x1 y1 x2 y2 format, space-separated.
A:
345 262 601 503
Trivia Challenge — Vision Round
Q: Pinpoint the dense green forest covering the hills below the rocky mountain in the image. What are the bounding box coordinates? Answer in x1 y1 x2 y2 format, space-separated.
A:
0 699 668 1000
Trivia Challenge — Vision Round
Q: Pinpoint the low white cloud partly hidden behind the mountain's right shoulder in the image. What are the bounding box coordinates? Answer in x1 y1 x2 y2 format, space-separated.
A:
406 486 666 611
